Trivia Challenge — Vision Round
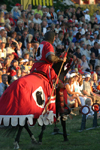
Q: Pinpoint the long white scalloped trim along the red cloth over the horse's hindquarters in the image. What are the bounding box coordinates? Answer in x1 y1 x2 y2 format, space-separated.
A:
0 114 34 126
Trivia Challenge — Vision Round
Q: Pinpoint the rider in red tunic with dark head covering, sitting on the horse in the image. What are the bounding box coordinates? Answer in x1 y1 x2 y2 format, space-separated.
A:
31 31 66 119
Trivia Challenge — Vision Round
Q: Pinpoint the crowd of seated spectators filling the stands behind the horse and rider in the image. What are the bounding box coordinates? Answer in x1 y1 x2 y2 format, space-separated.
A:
0 3 100 117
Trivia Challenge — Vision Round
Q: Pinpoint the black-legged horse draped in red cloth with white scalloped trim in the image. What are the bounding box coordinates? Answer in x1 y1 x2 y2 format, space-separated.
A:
0 56 72 149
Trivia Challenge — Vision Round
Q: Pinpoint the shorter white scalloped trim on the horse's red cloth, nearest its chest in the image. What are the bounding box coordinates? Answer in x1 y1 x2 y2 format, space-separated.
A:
38 111 56 126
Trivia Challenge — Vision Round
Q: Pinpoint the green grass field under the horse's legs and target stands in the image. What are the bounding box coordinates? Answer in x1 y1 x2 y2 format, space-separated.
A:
0 115 100 150
